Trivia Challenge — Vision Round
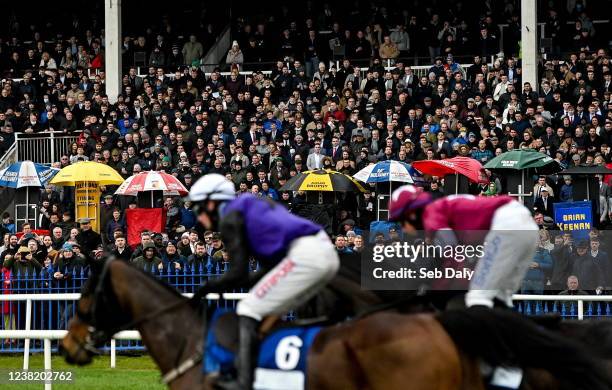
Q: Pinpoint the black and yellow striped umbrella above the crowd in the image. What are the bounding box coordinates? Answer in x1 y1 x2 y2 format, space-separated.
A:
281 169 366 192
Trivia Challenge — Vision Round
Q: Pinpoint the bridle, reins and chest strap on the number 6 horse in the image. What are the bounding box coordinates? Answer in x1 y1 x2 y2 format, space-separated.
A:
68 259 203 385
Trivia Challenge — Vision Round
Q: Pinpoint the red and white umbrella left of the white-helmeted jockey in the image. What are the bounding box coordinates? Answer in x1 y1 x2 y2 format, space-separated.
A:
115 171 189 196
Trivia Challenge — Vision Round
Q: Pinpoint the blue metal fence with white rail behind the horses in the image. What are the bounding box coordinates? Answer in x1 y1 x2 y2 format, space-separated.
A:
0 266 612 353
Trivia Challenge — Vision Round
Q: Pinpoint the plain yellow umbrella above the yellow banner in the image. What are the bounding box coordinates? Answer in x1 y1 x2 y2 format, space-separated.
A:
51 161 124 186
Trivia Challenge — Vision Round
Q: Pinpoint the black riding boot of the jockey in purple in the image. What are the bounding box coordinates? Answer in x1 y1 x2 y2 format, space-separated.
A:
215 316 259 390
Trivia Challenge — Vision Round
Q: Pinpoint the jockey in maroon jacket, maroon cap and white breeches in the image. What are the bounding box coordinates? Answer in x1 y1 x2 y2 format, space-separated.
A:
389 185 538 307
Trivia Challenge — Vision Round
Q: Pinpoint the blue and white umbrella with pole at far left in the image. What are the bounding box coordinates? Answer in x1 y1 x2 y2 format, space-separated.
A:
0 161 59 220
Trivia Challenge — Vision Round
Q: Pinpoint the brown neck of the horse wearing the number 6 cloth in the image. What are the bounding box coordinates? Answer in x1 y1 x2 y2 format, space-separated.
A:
111 261 204 388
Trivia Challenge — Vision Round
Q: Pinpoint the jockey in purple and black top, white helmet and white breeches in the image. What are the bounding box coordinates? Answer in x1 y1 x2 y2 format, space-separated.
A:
189 174 340 389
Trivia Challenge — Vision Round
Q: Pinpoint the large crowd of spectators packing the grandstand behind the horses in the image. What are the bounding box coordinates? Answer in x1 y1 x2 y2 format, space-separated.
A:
0 1 612 302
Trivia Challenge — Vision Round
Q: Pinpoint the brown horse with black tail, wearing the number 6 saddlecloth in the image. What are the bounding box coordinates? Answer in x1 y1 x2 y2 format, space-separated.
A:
61 260 609 390
